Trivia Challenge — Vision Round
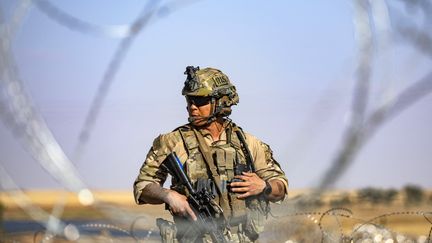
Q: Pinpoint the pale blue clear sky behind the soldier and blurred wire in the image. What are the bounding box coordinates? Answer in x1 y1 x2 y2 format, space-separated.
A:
0 0 432 190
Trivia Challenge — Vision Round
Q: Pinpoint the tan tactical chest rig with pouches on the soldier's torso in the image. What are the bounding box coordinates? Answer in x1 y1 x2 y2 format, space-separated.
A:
177 125 257 226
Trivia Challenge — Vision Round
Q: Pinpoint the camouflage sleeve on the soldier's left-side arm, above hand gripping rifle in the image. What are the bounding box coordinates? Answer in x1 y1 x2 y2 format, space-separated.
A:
134 132 183 204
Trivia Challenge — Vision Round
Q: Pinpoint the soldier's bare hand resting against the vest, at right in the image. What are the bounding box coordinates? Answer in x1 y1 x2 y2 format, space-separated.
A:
231 172 266 199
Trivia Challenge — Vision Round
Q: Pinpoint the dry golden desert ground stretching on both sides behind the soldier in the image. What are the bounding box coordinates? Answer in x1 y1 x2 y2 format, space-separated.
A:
0 190 432 243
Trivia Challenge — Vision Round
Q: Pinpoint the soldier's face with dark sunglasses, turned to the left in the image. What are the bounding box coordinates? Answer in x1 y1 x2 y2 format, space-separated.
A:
186 97 212 126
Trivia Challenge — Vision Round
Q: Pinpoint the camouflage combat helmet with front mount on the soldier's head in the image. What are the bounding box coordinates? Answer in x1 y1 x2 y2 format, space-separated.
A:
182 66 239 123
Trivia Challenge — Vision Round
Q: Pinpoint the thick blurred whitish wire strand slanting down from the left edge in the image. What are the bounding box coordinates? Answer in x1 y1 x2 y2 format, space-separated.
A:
0 0 93 200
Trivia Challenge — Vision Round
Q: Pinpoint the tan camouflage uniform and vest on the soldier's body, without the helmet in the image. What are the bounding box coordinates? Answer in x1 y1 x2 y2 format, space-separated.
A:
134 121 288 242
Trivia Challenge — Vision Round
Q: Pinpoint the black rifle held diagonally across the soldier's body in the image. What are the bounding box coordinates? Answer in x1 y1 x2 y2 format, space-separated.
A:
161 152 228 243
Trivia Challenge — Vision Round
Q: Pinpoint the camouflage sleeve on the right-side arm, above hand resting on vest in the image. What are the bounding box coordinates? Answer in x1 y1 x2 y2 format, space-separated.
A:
245 133 288 194
